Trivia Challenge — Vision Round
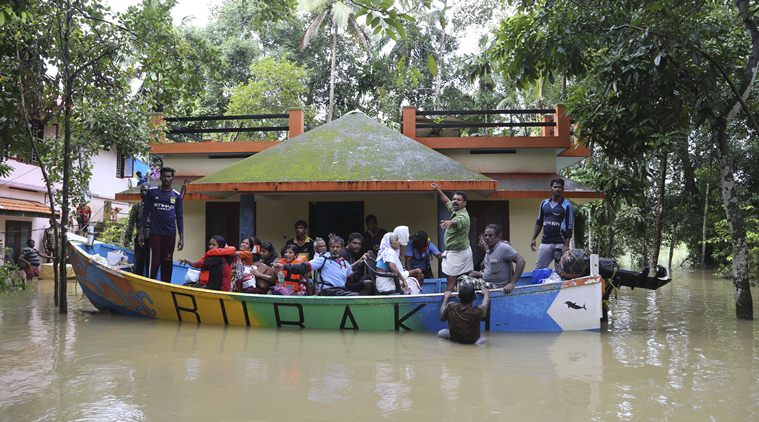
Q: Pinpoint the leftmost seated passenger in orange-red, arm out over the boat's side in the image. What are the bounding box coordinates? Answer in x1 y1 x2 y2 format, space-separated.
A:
179 235 235 292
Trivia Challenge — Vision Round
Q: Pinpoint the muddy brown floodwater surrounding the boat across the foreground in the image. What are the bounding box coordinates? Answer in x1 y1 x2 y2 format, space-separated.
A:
0 271 759 421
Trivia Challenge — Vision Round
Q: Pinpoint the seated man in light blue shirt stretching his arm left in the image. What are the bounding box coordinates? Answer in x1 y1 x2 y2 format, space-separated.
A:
274 236 364 296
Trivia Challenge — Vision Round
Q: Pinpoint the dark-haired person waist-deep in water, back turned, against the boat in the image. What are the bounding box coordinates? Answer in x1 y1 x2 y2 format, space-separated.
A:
437 283 490 344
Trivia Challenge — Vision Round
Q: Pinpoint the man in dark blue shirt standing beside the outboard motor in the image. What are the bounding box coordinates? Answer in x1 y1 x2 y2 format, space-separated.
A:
530 177 574 269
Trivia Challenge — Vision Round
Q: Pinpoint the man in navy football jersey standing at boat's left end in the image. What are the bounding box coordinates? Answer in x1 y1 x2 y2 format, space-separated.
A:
138 167 184 283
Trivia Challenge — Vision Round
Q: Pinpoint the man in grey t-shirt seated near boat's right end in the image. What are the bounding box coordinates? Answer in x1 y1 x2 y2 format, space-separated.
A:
469 224 525 293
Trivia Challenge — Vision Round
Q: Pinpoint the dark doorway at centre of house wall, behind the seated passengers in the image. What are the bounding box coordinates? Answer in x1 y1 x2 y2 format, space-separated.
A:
308 201 364 241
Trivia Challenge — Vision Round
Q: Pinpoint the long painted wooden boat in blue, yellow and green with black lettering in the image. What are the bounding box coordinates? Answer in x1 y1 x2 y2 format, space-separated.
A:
68 242 604 332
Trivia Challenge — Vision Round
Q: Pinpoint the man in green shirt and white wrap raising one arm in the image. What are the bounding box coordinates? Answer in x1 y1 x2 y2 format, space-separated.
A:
432 183 474 291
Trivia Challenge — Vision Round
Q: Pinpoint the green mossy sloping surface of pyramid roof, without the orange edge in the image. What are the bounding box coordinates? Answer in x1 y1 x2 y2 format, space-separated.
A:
195 113 490 183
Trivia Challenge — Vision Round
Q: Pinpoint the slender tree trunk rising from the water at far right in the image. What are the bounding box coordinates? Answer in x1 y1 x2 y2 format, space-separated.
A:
712 118 754 320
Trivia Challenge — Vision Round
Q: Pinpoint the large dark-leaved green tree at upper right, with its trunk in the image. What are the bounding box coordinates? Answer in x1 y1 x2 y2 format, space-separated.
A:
487 0 759 318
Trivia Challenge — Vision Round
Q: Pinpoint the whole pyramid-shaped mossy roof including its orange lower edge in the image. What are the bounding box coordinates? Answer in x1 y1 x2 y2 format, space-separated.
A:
188 112 496 192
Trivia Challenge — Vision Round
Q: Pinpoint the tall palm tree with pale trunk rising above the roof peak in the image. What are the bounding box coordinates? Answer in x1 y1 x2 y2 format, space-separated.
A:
300 0 371 122
